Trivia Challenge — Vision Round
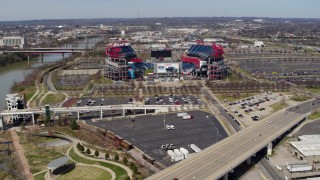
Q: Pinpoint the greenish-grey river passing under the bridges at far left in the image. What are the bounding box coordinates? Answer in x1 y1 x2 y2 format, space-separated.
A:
0 37 101 110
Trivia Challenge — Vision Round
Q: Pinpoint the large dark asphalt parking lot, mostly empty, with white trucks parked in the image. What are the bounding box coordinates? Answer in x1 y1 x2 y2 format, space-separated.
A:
87 111 227 166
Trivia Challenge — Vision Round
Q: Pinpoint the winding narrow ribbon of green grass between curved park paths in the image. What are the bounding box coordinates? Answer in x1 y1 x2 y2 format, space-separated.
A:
69 148 128 180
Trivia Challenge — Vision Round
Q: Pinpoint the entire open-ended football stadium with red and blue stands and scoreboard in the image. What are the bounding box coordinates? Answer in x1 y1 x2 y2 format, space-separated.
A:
103 41 228 81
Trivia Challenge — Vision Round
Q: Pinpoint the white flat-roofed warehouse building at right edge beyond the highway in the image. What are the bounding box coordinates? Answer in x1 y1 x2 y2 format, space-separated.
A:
289 135 320 162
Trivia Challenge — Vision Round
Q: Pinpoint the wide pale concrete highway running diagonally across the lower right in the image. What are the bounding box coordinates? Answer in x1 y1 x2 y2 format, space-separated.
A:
148 100 320 180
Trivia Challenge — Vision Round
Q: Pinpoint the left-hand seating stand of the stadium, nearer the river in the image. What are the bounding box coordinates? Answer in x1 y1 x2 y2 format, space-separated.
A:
103 43 142 81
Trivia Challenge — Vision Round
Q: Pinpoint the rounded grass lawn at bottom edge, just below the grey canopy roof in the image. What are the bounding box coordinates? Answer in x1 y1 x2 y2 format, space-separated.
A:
57 166 112 180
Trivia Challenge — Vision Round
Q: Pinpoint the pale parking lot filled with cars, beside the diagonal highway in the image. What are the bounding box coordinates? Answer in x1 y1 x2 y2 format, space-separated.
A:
228 93 289 126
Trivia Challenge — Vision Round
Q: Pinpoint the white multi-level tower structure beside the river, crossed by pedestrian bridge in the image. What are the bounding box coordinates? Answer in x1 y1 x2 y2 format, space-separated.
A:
4 94 29 124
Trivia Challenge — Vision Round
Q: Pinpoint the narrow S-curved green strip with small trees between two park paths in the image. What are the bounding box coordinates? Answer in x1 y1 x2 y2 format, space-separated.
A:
69 147 132 180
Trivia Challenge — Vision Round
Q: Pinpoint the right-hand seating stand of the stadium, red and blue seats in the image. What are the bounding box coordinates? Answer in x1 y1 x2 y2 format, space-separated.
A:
181 41 228 80
